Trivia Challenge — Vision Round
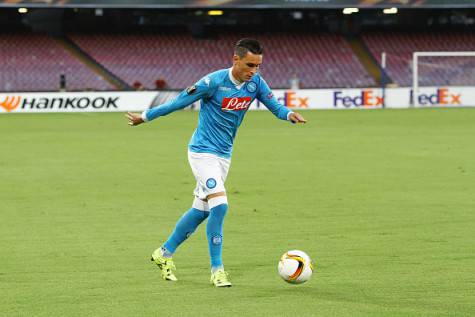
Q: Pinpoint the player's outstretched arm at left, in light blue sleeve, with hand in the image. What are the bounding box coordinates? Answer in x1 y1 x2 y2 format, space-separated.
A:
126 77 216 126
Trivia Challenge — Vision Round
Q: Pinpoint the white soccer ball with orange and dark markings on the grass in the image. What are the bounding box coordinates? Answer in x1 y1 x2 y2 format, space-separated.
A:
278 250 313 284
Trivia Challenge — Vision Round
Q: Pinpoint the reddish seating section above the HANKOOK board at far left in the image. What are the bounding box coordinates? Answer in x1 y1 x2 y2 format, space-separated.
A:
0 33 113 91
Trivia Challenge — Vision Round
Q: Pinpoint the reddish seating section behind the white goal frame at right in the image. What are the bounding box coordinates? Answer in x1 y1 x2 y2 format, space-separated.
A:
362 31 475 86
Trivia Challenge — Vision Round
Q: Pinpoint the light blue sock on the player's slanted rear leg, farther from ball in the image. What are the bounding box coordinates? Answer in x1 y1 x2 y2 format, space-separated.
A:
163 208 209 255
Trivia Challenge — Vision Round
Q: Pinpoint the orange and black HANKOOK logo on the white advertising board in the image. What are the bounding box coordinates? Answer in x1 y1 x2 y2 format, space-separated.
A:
0 96 119 112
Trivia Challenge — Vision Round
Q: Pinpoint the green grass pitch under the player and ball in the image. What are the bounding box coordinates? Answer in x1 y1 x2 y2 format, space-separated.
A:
0 109 475 317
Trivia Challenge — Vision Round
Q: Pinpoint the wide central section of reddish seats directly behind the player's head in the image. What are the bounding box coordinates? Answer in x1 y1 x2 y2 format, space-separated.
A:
70 34 375 89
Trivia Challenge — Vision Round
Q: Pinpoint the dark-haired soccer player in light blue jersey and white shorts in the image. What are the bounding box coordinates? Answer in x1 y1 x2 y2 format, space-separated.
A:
126 39 306 287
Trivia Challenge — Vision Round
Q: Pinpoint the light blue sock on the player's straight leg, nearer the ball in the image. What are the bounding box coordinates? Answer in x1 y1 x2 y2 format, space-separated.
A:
206 201 228 272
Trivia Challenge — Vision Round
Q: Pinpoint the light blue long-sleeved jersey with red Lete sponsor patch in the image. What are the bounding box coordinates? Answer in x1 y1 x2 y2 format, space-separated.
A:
142 69 291 159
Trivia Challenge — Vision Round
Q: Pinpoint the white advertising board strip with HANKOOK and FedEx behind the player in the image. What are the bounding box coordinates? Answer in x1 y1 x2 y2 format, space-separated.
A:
0 87 475 114
